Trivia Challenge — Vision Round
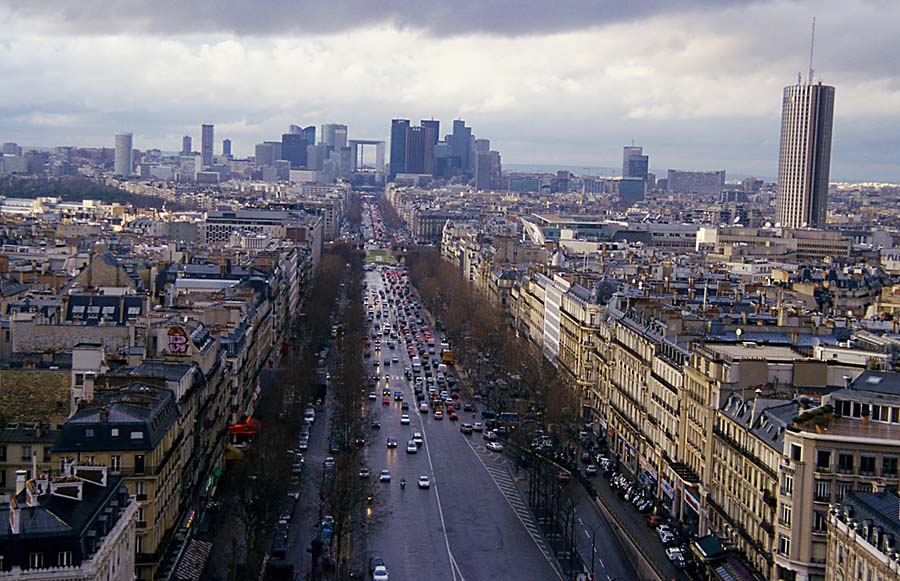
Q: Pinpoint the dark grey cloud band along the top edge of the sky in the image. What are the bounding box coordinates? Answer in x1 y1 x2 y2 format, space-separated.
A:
0 0 756 36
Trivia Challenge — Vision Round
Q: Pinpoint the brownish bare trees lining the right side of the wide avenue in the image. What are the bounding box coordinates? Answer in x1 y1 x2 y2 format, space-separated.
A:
407 247 579 441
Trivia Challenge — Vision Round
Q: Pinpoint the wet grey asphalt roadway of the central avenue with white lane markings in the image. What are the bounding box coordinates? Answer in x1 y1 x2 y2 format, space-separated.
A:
365 271 560 581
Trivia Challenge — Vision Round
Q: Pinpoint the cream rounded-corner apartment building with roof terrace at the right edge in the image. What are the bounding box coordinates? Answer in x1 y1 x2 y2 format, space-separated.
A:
775 371 900 581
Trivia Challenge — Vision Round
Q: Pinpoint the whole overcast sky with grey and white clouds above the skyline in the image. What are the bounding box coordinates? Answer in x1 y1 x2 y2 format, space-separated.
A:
0 0 900 182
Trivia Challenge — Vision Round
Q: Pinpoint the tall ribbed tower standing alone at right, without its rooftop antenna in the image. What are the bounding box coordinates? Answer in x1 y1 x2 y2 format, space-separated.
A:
778 82 834 228
